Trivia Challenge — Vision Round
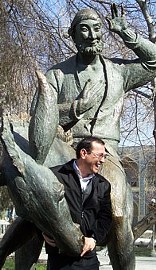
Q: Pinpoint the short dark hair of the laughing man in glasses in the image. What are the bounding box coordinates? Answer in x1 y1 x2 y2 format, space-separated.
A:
76 136 105 158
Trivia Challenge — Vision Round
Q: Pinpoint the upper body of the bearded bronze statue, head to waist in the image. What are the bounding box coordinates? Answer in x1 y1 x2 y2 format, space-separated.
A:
46 5 156 149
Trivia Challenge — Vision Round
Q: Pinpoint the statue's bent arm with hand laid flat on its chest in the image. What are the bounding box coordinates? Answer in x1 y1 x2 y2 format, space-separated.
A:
46 70 99 131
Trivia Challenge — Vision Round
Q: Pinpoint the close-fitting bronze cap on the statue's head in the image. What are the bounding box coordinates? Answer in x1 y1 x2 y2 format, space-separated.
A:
68 8 102 39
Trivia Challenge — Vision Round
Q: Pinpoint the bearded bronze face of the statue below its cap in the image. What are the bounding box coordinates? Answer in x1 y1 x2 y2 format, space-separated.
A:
74 19 102 55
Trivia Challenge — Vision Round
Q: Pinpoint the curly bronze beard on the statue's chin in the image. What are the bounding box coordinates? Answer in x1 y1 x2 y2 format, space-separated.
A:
77 41 103 55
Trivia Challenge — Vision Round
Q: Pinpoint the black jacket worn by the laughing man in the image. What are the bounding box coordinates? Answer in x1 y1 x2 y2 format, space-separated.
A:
51 160 112 243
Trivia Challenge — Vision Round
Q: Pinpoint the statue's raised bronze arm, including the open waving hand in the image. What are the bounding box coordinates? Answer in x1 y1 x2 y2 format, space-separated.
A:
106 4 156 91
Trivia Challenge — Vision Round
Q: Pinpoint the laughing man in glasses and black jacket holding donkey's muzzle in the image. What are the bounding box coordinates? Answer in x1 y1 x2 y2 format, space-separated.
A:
43 137 112 270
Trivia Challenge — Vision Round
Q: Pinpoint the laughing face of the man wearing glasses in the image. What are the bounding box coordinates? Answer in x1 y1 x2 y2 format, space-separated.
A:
81 142 106 175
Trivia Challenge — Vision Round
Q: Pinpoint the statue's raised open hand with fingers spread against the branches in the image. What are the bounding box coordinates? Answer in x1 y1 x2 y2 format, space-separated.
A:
106 3 128 34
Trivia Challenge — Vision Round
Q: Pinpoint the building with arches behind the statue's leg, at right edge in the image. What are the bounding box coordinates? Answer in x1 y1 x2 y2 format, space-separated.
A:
119 145 156 225
